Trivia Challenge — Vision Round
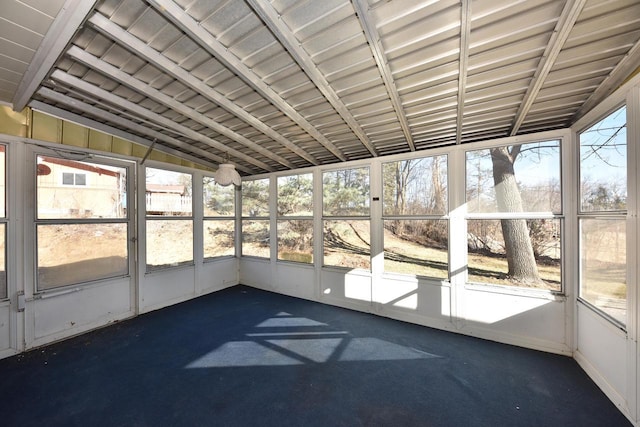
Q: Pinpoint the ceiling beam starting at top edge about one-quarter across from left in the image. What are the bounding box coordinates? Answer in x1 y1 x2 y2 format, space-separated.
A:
144 0 348 161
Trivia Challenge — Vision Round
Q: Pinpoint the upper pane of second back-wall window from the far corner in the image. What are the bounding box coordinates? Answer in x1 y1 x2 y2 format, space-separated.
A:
278 173 313 216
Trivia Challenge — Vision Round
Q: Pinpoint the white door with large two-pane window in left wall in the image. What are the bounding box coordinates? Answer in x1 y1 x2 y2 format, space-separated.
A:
23 146 137 349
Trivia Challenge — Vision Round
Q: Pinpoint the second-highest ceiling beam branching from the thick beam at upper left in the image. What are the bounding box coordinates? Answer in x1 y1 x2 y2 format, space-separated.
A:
67 46 295 169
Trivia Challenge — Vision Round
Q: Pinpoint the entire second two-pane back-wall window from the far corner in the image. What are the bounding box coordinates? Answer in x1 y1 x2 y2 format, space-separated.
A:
277 173 313 264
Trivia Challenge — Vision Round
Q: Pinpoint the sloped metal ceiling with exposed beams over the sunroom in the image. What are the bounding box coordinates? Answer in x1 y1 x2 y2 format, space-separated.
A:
0 0 640 175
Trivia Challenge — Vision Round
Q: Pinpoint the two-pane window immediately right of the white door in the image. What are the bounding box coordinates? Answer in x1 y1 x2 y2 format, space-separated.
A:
145 168 193 271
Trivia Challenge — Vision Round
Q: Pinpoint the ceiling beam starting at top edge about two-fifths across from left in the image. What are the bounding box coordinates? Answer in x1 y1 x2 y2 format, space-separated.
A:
246 0 378 157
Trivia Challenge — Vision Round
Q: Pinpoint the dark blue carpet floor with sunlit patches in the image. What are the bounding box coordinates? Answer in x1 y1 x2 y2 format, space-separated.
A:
0 286 630 427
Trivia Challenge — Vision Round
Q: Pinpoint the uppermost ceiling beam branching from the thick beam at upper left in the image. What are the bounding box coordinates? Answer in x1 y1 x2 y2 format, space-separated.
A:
89 13 319 167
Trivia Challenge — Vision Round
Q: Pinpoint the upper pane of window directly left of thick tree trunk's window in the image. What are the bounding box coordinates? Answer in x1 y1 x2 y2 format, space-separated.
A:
382 156 447 216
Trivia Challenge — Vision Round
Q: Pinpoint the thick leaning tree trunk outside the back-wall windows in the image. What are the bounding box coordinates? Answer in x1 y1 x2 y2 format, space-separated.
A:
491 147 542 285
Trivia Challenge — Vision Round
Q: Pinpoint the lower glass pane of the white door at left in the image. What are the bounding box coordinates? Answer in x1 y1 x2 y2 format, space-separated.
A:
37 223 128 290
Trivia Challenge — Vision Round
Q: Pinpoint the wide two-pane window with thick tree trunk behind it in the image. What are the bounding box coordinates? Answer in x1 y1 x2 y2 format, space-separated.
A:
466 140 563 292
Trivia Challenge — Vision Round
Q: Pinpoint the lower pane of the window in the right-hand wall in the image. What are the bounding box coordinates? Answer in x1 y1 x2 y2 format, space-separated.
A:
580 219 627 324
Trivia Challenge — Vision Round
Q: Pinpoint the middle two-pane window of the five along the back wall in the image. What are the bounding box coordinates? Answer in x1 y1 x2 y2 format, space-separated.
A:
322 167 371 270
